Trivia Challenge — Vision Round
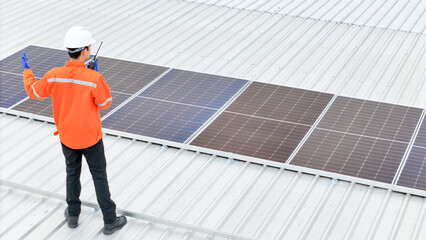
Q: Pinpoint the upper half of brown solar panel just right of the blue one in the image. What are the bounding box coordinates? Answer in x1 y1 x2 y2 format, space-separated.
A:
226 82 333 125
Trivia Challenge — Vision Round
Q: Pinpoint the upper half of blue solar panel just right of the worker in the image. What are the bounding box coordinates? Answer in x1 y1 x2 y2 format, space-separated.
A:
139 69 247 109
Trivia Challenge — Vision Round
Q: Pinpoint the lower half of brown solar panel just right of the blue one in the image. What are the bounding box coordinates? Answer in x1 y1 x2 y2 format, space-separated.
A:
191 112 310 162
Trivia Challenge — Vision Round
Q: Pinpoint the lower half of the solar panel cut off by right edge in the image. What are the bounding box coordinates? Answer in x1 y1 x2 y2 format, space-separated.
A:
397 146 426 191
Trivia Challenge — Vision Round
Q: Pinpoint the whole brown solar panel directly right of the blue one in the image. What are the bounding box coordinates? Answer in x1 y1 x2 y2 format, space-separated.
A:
191 82 332 162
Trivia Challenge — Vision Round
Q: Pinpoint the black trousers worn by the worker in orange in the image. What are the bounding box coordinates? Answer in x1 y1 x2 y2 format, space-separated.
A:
62 139 117 224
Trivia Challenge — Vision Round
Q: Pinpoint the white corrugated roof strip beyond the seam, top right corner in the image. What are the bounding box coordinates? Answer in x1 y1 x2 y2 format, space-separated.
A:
187 0 426 33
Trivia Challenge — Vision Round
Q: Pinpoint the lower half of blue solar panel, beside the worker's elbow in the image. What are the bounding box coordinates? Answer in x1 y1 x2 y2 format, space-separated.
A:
102 97 216 143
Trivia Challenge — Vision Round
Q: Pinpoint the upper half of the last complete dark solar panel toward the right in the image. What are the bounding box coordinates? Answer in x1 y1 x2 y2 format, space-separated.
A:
318 97 422 142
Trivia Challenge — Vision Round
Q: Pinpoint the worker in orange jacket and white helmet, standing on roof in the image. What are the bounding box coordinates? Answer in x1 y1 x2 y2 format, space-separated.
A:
22 26 127 235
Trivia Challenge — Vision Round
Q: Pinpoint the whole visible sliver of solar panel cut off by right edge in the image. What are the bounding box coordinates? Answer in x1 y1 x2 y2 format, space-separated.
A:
397 118 426 191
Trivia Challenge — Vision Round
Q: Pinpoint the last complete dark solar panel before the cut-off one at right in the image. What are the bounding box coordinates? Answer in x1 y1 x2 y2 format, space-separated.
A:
291 97 422 183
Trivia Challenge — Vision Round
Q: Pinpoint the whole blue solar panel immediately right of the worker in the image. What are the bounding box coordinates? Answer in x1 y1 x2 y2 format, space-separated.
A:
103 69 248 142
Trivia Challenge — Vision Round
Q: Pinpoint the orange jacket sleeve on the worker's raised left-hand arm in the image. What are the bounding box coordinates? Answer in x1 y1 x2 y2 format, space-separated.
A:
24 69 52 100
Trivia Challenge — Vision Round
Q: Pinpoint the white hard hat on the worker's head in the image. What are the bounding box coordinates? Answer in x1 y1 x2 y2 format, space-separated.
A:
64 26 96 48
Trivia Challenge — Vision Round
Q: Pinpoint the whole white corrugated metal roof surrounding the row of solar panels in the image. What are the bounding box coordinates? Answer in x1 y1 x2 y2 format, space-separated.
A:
0 0 426 239
